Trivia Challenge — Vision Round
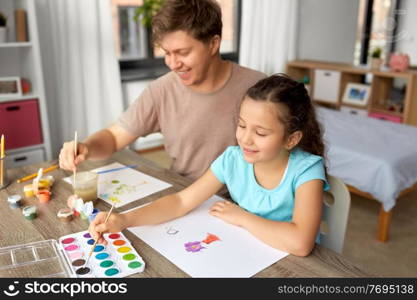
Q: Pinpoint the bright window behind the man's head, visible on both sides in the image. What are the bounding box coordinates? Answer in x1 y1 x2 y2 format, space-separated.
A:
111 0 241 68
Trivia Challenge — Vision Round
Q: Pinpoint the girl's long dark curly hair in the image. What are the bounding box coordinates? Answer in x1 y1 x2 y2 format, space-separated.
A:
246 74 324 157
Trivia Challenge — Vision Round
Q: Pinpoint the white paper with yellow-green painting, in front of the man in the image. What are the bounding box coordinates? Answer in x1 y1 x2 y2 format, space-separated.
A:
64 162 172 208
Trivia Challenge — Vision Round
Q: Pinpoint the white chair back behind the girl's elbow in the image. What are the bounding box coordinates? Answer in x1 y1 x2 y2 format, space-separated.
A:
320 175 350 253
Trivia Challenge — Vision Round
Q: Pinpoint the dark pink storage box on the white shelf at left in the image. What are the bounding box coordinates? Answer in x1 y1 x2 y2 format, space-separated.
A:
0 99 43 150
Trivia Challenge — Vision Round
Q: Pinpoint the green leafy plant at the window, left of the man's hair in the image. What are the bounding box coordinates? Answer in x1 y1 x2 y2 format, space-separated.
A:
134 0 165 58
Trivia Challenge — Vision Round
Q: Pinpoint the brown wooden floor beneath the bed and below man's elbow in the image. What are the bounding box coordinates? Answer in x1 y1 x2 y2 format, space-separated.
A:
141 149 417 277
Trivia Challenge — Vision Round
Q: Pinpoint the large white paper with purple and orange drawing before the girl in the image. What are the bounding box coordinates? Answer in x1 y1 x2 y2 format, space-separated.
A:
129 196 288 277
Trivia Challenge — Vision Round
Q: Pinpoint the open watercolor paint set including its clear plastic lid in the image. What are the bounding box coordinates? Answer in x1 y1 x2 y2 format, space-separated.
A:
0 231 145 278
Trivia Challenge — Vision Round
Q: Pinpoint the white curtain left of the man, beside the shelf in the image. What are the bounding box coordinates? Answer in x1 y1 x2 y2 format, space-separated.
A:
36 0 123 156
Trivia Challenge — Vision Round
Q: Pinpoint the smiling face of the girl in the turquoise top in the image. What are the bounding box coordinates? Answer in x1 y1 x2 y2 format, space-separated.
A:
236 97 286 163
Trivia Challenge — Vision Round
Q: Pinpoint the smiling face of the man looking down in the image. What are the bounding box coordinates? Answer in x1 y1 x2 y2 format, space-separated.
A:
160 30 217 87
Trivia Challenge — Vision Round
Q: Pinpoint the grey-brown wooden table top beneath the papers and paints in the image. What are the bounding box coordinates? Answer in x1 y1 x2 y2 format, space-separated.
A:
0 150 374 277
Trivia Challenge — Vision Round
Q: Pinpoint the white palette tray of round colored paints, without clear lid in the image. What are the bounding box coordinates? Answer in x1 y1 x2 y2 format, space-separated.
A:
58 231 145 277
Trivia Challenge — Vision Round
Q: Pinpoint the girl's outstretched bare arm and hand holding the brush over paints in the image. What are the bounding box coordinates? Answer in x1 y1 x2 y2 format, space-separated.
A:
89 169 223 242
